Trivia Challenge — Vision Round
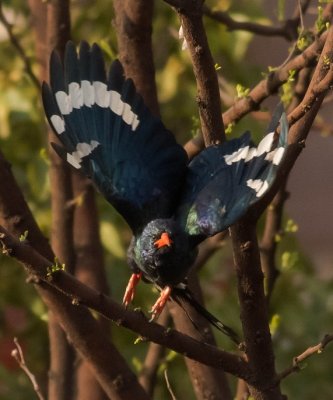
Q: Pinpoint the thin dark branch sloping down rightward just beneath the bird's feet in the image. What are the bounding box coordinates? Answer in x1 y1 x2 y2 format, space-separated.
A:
0 227 249 379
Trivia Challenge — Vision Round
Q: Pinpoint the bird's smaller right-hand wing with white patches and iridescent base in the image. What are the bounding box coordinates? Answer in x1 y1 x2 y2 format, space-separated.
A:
178 106 288 242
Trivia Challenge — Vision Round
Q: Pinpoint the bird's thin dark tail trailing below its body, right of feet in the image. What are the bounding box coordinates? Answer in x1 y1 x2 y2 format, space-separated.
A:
171 286 241 345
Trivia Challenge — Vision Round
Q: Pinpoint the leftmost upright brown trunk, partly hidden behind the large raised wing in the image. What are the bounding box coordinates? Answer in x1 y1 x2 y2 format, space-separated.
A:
44 0 75 400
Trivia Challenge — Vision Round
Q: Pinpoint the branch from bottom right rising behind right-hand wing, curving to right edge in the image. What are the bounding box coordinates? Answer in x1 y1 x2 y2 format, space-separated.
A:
231 21 333 399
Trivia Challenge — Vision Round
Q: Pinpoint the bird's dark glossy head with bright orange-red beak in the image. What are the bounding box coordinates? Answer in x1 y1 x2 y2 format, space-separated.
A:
135 219 195 287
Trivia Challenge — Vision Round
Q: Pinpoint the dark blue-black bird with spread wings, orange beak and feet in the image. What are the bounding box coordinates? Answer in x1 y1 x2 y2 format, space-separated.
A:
42 41 288 343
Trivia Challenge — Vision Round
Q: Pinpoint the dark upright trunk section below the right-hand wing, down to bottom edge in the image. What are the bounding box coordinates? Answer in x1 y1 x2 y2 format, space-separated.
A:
231 219 281 400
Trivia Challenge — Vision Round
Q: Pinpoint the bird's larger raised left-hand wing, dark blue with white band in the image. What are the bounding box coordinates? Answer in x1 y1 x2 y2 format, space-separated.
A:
42 42 187 231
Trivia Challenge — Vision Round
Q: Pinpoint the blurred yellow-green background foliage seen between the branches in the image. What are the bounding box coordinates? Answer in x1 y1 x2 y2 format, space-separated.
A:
0 0 333 400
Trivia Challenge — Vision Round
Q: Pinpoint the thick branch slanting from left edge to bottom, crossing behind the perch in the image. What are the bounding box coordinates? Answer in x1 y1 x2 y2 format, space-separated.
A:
0 149 147 400
